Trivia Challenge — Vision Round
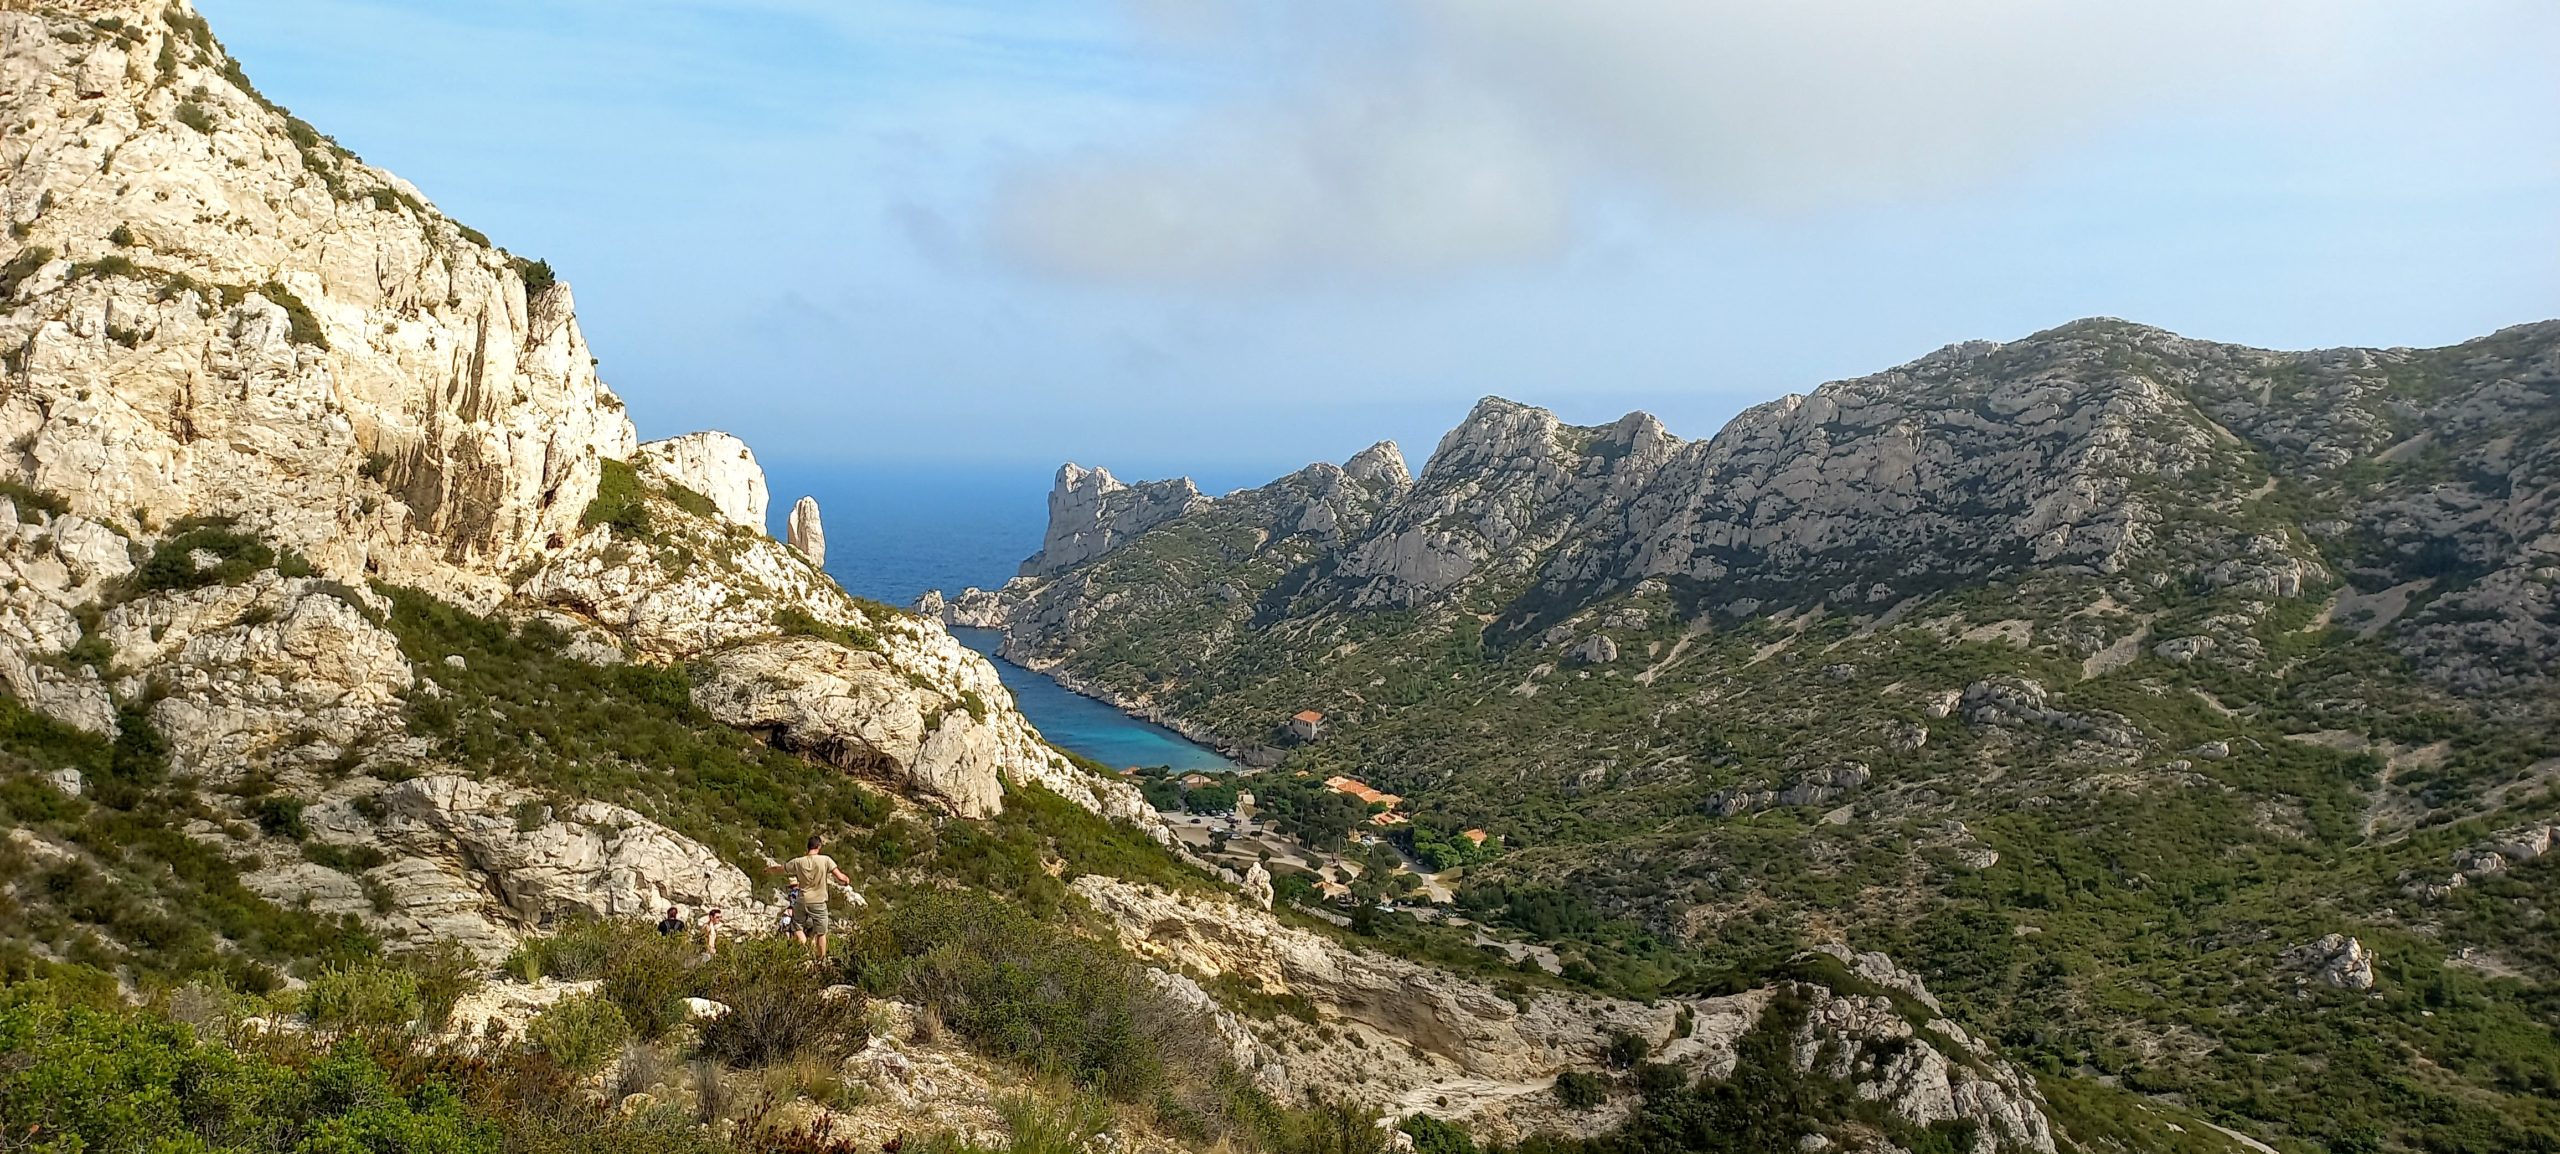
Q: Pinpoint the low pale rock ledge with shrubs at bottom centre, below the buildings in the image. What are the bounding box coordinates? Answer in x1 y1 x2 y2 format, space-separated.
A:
1073 875 2056 1154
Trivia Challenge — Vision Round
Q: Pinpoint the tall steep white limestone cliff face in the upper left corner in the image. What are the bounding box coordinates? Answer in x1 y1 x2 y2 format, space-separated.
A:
0 0 632 609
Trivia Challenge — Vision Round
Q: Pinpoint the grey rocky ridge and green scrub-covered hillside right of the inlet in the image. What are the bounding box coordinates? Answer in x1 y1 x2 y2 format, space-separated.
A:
945 320 2560 1151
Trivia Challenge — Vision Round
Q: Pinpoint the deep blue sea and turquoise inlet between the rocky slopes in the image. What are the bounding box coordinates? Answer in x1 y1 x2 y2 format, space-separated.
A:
765 461 1236 773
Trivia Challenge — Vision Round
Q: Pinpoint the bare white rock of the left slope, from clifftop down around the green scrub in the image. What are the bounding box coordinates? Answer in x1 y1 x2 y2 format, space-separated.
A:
0 0 1152 967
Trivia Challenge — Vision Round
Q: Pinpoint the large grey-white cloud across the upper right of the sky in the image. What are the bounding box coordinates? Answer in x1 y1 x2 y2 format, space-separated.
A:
993 0 2550 284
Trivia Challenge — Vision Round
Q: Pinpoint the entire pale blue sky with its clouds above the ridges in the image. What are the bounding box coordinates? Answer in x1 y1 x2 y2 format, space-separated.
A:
197 0 2560 491
